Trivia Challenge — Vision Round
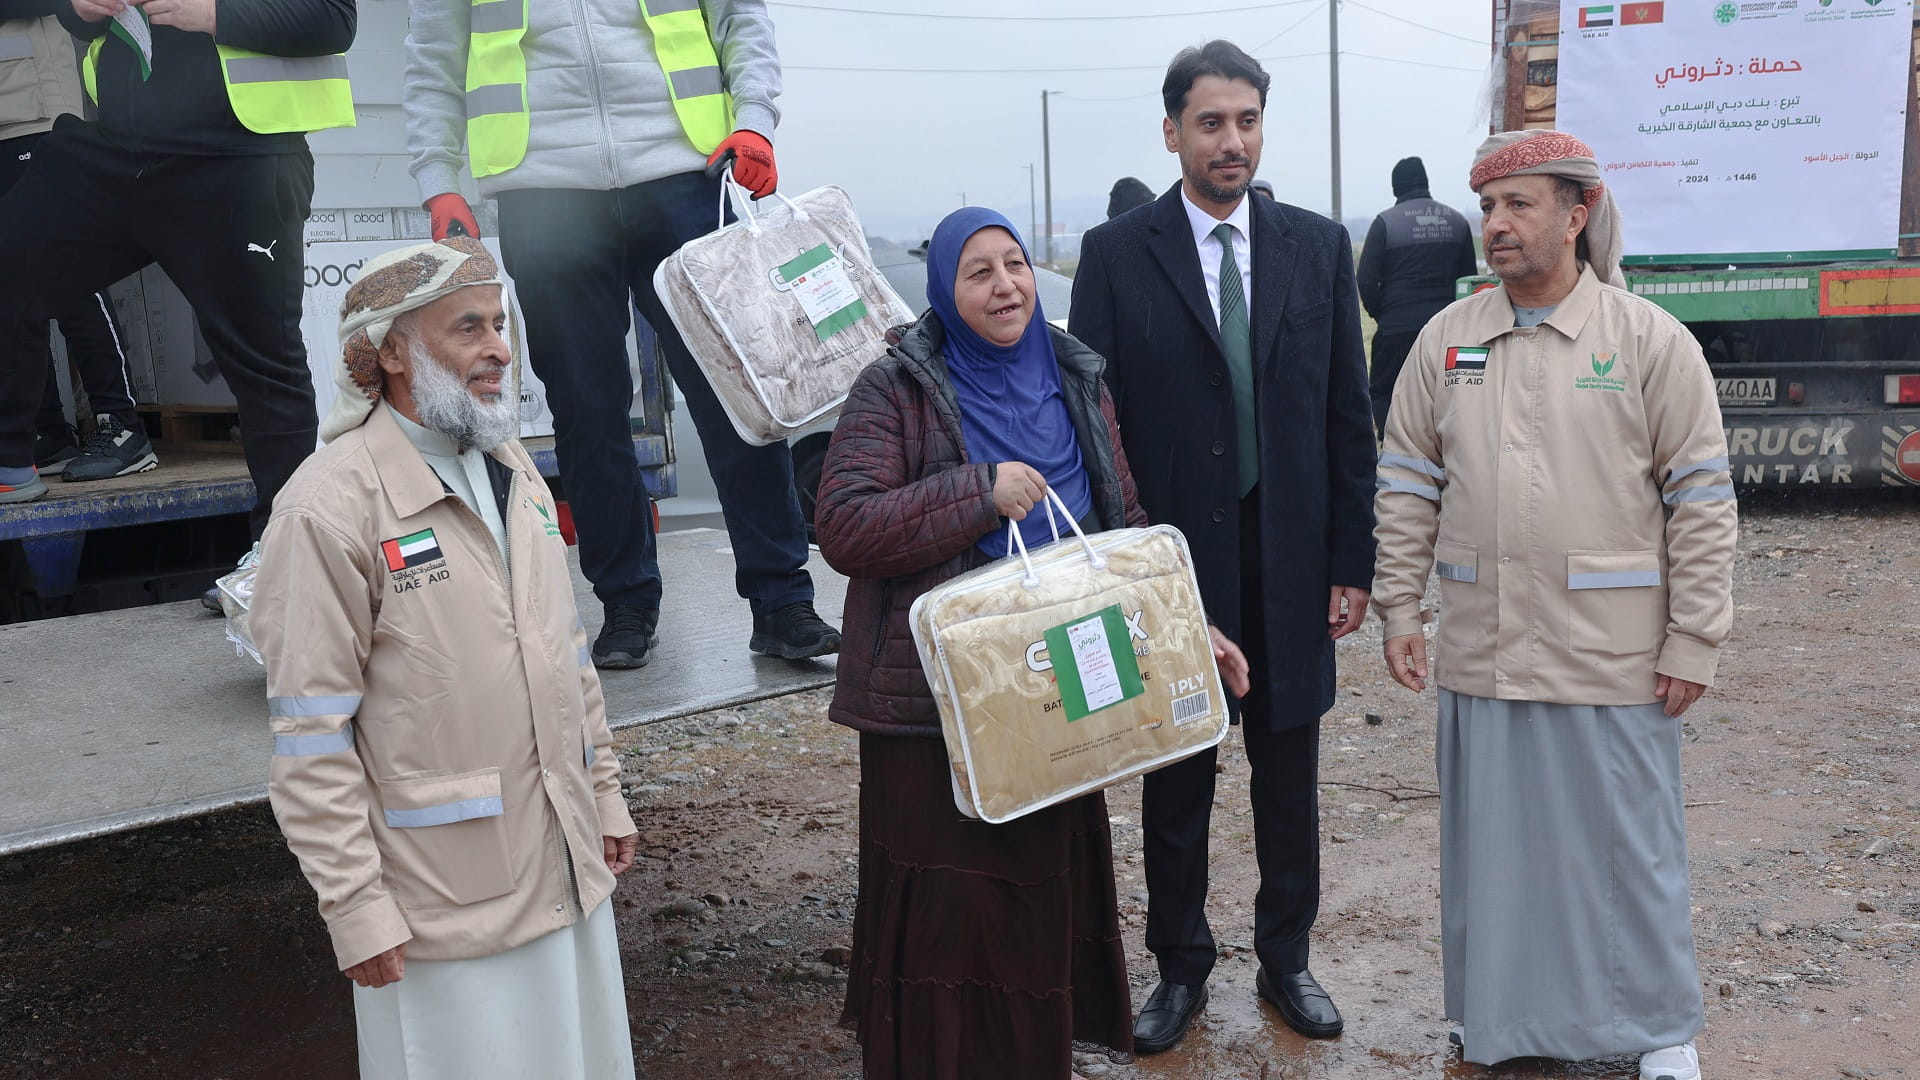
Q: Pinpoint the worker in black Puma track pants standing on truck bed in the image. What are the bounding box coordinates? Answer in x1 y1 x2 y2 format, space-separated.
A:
0 0 357 584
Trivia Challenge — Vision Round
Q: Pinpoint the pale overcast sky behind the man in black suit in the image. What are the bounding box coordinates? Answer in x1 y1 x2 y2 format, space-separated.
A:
768 0 1492 238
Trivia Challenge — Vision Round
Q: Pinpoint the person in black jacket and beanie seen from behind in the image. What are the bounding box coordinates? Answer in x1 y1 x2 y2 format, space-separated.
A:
1359 158 1480 432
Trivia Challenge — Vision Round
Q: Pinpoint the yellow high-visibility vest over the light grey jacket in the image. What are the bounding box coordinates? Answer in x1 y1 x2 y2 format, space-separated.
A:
467 0 733 177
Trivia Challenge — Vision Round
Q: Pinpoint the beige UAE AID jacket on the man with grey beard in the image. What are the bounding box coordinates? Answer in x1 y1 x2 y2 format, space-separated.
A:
252 407 636 969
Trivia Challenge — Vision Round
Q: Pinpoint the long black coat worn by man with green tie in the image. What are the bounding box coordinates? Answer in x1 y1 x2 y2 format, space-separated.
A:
1068 184 1375 728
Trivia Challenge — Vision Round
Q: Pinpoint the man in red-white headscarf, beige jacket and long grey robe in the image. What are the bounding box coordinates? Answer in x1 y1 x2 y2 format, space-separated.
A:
1373 131 1736 1080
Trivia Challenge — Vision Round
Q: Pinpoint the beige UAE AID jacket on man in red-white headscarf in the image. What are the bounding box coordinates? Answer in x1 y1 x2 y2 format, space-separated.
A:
1373 267 1736 705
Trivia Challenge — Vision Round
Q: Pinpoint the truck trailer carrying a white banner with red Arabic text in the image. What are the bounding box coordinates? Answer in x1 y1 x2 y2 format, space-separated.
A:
1482 0 1920 488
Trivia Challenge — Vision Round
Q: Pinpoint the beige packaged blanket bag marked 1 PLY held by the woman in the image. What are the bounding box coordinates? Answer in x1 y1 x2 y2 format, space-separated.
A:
910 492 1227 822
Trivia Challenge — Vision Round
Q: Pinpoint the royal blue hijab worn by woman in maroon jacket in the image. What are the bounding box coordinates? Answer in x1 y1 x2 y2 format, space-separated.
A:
927 206 1092 559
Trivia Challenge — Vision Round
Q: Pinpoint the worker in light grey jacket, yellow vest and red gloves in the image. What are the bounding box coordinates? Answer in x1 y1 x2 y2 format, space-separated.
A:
405 0 839 669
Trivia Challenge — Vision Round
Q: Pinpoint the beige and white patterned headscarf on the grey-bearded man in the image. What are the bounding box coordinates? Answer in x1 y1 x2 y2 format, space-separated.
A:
321 236 518 442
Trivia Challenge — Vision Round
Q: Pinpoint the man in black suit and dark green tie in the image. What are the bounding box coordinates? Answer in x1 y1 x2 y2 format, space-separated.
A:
1069 40 1373 1053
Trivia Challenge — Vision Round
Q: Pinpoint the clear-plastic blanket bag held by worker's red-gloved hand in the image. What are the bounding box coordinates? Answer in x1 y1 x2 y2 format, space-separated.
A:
653 173 914 446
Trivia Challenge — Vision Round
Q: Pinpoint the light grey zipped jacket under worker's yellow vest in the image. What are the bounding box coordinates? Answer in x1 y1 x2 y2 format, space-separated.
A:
405 0 780 202
